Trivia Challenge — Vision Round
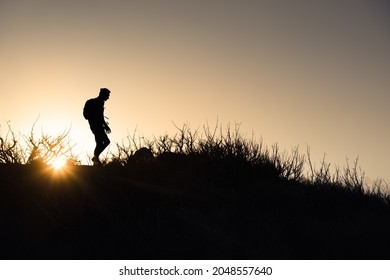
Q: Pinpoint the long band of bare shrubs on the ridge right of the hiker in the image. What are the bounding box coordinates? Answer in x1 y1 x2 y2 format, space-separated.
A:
103 121 385 195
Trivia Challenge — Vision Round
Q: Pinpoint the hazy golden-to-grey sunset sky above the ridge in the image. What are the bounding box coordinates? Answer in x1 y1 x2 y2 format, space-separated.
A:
0 0 390 182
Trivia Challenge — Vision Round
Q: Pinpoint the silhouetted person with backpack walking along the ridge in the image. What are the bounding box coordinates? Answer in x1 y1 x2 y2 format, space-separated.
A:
83 88 111 166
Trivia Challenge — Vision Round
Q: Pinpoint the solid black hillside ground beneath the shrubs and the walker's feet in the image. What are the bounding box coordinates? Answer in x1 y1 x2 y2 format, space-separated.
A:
0 160 390 259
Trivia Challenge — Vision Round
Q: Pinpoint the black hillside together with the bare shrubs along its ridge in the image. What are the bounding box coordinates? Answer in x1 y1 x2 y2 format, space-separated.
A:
0 120 390 259
